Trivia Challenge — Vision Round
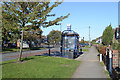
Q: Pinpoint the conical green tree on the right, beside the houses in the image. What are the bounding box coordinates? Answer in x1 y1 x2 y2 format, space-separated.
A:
102 25 114 46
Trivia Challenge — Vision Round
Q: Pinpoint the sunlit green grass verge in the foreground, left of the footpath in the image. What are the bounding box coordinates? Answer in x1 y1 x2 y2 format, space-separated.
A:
2 56 81 78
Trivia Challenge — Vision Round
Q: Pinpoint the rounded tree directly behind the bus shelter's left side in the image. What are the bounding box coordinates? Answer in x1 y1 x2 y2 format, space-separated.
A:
48 30 61 44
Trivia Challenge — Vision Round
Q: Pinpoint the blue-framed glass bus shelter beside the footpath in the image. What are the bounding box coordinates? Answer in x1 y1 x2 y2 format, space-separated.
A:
61 30 79 59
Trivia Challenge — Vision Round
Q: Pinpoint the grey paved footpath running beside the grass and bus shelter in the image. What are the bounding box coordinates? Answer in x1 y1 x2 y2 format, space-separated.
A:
72 46 108 78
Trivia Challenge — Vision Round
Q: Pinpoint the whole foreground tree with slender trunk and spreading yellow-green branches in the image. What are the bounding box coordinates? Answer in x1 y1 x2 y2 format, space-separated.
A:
2 2 70 61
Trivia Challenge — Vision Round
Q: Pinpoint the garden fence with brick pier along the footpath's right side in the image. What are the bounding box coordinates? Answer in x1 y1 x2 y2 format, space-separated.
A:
94 45 120 79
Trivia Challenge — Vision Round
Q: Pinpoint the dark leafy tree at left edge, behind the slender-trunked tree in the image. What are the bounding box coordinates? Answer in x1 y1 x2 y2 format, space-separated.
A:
1 11 20 44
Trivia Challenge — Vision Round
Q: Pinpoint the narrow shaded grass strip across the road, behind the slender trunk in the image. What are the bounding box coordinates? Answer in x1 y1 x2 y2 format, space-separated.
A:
2 47 45 53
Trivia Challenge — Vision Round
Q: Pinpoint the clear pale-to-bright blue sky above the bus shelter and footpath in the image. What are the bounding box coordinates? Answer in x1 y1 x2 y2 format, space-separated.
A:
42 2 118 40
